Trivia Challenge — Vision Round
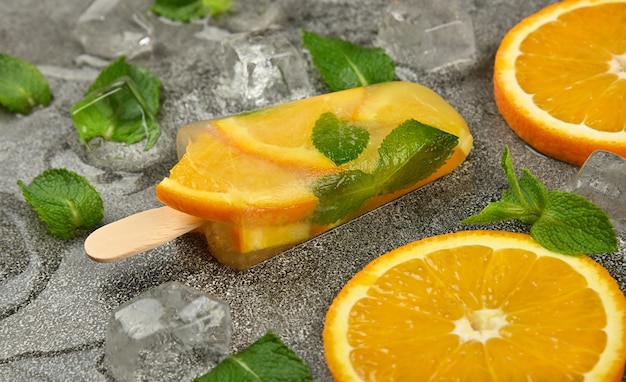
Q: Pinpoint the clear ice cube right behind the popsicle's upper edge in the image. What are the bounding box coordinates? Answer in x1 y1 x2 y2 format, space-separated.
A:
220 29 313 107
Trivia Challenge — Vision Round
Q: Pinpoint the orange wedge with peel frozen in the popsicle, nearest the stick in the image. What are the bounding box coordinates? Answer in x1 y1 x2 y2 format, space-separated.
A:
156 132 317 225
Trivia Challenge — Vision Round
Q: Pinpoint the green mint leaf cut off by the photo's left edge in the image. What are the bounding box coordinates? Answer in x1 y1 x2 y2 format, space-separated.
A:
0 53 52 114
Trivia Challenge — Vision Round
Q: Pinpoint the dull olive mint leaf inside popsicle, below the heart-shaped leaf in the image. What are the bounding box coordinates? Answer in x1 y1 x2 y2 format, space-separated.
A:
311 170 377 225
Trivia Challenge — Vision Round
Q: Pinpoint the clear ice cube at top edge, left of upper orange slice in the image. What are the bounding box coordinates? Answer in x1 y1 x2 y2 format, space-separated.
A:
377 0 476 71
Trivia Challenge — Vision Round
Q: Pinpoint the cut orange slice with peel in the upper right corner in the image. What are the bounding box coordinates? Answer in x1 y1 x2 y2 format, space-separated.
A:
494 0 626 165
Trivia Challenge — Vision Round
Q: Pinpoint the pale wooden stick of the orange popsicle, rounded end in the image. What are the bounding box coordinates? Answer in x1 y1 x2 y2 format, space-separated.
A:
85 207 206 263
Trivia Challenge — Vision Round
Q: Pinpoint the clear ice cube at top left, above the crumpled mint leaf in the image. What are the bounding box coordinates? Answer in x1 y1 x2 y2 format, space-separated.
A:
73 0 153 59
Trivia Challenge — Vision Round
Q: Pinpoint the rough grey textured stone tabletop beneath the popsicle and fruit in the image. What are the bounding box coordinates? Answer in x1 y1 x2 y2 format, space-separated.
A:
0 0 626 381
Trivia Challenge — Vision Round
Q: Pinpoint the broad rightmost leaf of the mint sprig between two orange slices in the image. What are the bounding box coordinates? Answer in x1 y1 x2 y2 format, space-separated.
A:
530 191 618 255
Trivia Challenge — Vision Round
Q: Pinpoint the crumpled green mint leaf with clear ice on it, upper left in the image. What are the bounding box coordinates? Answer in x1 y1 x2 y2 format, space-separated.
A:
70 56 161 150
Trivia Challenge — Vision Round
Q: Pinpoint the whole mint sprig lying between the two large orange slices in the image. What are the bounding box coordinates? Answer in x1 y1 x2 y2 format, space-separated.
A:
462 147 618 255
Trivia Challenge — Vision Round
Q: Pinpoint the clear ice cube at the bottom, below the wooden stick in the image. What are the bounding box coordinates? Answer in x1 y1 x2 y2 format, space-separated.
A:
105 282 232 381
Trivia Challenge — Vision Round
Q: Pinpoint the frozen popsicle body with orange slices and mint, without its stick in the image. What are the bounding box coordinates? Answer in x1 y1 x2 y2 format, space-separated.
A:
156 81 473 270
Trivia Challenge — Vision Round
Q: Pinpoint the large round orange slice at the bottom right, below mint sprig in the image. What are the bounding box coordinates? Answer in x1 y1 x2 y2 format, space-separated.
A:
323 231 626 382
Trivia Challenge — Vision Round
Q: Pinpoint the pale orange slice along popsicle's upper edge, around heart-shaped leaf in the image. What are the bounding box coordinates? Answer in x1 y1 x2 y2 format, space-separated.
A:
215 81 473 170
